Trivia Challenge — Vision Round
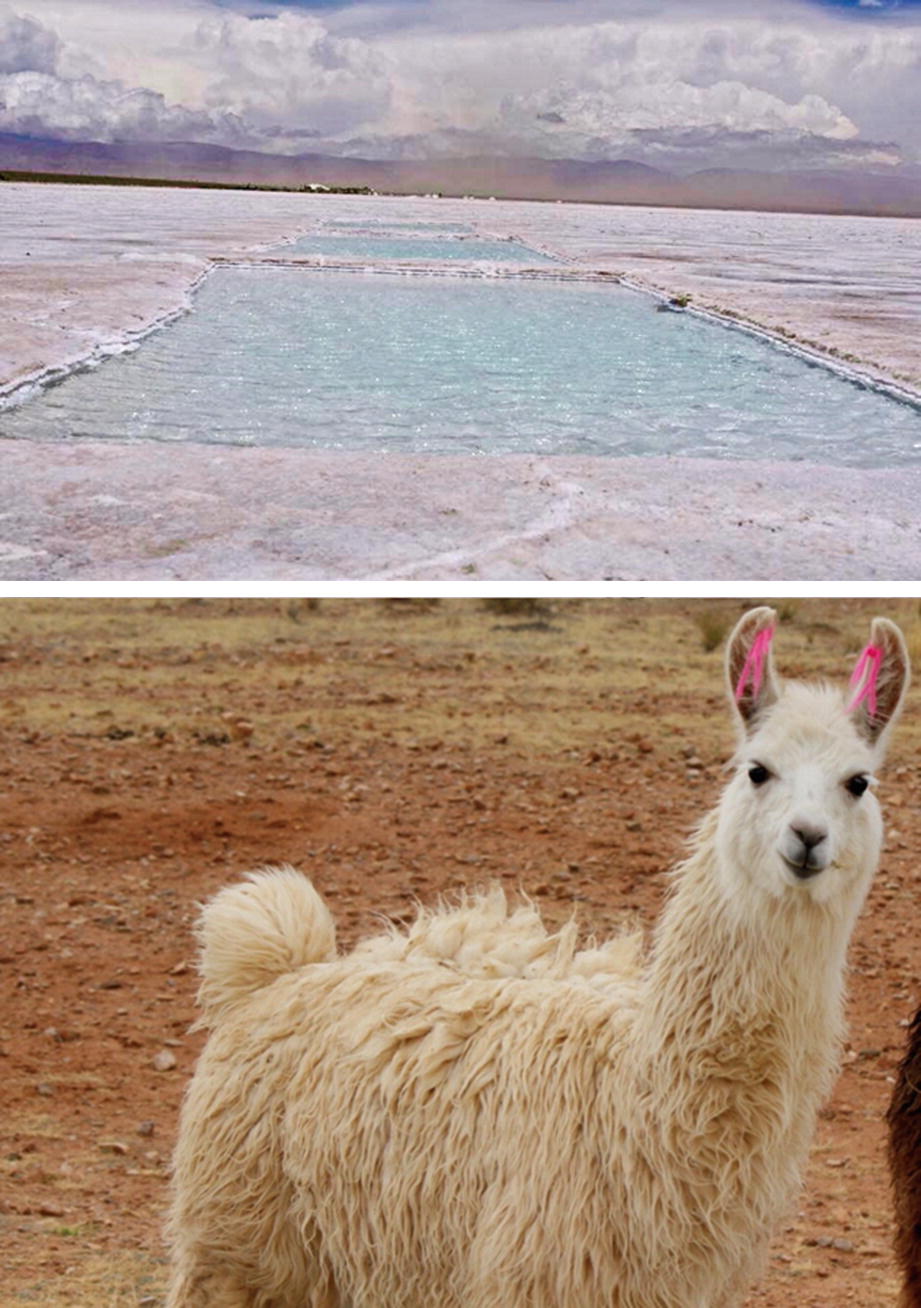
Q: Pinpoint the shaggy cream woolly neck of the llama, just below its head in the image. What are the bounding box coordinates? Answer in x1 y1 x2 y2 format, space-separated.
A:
637 810 852 1119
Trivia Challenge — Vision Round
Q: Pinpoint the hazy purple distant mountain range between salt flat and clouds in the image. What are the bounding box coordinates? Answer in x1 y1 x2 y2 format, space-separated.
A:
0 132 921 217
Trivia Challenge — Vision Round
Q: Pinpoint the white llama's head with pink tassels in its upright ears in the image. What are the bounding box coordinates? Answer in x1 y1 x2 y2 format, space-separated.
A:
717 608 909 909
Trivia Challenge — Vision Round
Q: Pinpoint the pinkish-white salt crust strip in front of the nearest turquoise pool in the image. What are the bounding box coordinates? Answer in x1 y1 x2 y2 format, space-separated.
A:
0 441 921 582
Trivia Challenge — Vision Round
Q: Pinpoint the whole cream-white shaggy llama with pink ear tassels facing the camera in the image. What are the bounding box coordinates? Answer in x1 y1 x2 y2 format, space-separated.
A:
167 607 908 1308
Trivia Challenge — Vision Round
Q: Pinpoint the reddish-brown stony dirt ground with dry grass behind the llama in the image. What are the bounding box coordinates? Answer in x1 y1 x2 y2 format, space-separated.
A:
0 599 921 1308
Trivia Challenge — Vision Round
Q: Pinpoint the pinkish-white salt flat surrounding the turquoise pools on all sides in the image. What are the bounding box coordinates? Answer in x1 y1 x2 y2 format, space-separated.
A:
0 183 921 581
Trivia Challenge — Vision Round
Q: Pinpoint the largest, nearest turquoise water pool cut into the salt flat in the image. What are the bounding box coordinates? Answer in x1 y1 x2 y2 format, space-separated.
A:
0 267 921 467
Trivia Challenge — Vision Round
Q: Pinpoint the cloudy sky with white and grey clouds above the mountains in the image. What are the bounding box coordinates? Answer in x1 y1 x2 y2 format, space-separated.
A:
0 0 921 173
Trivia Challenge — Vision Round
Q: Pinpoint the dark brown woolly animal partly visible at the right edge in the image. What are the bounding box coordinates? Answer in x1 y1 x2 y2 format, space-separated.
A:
886 1008 921 1308
